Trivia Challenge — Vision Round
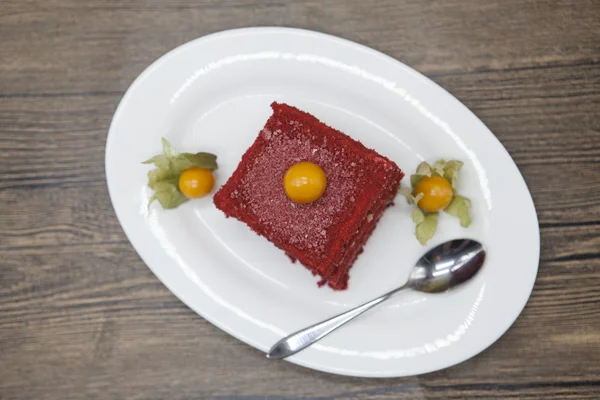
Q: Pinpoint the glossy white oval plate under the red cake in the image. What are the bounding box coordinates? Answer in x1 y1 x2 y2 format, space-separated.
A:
106 28 539 377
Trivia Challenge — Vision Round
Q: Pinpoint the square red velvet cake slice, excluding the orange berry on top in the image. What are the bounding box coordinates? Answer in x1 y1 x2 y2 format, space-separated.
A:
214 103 404 290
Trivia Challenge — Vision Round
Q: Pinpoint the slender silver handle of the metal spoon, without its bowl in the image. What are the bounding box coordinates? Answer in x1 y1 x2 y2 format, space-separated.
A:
267 285 407 359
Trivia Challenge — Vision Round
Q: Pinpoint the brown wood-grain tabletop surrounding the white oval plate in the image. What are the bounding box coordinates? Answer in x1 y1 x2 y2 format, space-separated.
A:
0 0 600 400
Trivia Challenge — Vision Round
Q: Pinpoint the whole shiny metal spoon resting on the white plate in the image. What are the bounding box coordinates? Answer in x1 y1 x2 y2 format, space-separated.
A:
267 239 485 359
